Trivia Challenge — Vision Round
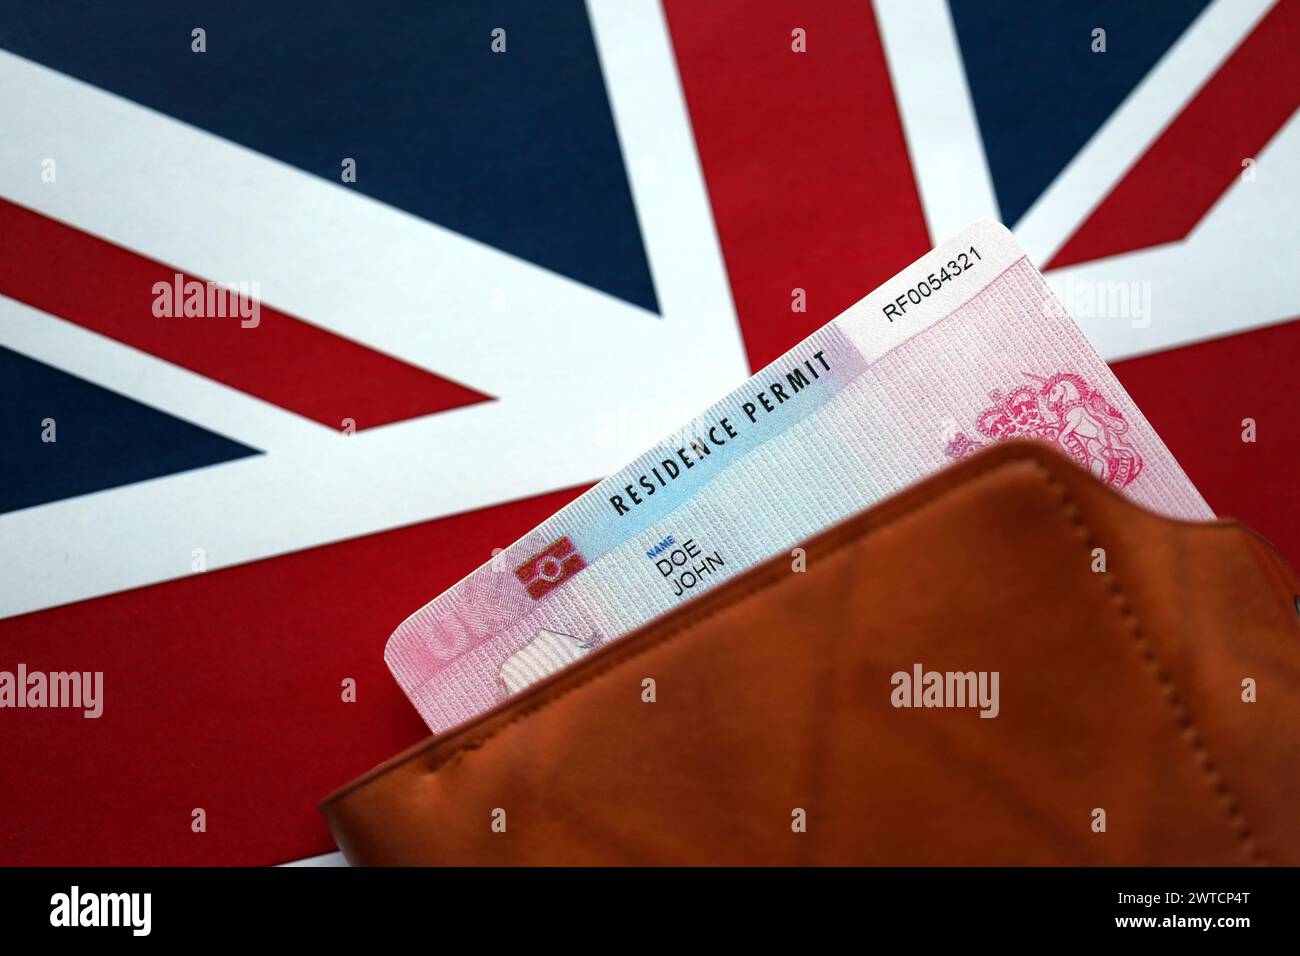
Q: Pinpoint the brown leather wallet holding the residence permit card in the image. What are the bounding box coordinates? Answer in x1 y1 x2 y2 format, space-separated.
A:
321 442 1300 865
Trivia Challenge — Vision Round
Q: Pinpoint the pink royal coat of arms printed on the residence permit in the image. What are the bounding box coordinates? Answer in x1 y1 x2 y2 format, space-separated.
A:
944 372 1143 488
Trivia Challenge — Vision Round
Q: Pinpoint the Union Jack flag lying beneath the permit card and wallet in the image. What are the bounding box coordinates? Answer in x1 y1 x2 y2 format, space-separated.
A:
0 0 1300 864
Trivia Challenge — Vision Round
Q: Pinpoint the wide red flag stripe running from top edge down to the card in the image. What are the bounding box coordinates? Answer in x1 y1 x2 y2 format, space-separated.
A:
666 0 930 369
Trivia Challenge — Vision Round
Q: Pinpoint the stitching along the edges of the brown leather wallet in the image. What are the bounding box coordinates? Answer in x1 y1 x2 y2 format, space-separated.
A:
424 457 1262 862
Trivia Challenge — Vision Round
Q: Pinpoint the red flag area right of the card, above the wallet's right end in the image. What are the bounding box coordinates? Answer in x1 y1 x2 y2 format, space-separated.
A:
1112 321 1300 567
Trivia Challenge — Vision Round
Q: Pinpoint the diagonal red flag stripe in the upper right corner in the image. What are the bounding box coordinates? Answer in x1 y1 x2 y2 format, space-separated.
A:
1048 0 1300 269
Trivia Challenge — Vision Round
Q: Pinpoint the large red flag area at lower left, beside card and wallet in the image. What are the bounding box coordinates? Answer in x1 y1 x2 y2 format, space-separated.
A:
0 489 584 865
